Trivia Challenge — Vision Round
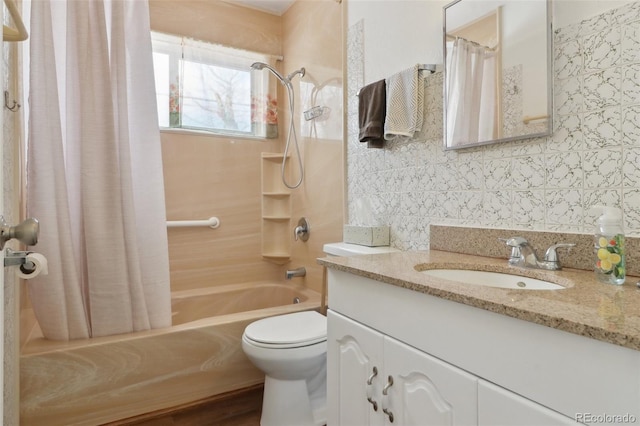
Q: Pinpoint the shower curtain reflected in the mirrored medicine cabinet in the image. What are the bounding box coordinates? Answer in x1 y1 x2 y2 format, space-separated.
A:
446 37 498 146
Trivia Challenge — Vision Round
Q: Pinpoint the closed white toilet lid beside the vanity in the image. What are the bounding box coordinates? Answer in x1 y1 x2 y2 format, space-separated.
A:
244 311 327 348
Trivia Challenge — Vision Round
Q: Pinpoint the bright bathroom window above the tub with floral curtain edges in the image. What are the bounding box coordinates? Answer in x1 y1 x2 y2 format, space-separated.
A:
151 32 278 137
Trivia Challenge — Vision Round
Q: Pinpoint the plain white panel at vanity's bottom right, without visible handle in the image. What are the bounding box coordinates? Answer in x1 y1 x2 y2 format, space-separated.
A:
478 380 580 426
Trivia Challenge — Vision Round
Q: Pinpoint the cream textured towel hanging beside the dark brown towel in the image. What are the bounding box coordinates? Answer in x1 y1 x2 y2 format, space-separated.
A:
384 65 424 140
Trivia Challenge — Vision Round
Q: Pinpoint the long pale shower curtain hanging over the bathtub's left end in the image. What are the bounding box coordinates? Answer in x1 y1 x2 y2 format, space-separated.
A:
27 0 171 340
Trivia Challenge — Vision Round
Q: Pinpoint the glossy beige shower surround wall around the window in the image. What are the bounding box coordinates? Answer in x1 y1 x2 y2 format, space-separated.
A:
154 0 344 291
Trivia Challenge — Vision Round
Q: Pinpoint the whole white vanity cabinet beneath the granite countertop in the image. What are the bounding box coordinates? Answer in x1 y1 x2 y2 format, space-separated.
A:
327 268 640 426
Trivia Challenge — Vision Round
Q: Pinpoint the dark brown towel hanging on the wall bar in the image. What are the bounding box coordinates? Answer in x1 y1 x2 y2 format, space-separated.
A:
358 80 387 148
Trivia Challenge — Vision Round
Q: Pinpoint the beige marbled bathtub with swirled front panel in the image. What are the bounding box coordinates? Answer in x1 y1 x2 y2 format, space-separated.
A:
20 282 321 426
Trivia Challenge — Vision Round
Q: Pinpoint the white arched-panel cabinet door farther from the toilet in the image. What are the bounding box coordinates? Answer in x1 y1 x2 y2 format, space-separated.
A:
382 337 478 426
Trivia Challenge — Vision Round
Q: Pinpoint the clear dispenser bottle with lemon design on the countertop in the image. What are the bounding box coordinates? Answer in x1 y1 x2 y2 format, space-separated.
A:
592 206 626 285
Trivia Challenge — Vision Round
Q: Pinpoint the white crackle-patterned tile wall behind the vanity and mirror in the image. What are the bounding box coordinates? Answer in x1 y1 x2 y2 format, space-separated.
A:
347 2 640 249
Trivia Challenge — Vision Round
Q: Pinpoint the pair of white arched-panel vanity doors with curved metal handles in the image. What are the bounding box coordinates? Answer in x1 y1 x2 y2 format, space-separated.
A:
327 311 477 426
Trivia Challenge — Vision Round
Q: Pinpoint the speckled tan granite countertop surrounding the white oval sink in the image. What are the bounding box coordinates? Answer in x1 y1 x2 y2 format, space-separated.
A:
318 250 640 350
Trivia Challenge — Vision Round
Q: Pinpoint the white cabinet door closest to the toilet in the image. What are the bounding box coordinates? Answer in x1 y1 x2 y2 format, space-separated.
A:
327 310 384 426
